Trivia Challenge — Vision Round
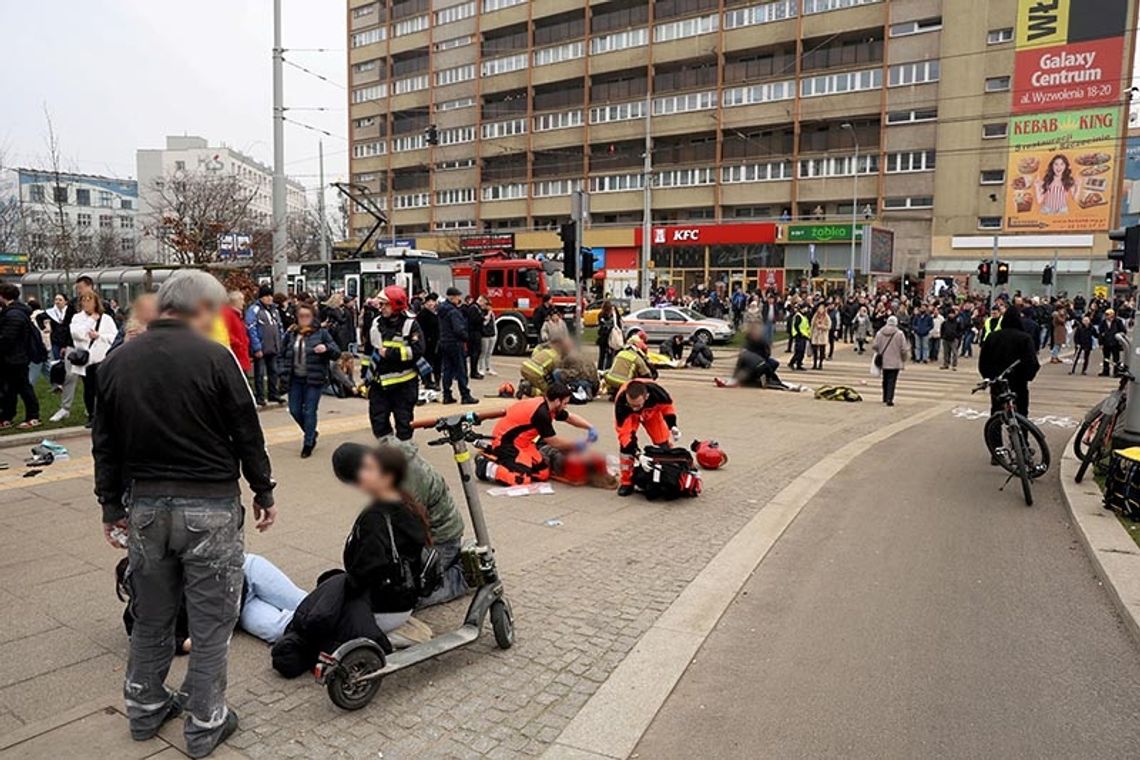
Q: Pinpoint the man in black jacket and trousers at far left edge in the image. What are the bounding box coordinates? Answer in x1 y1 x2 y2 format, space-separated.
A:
0 283 47 427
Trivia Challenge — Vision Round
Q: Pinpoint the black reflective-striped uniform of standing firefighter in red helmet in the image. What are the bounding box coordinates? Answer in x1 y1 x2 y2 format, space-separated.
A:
368 312 424 441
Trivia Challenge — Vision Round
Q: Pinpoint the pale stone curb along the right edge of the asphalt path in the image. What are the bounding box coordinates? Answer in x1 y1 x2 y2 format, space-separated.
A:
1060 433 1140 644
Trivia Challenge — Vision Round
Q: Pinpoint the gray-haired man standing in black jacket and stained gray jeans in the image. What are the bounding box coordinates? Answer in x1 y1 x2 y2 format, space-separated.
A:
91 270 277 758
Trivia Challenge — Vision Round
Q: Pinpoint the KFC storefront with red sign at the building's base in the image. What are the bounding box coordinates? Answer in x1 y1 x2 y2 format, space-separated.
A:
634 223 784 293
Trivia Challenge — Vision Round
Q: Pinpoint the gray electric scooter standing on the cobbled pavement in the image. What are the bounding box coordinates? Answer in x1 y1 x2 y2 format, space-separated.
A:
314 410 514 710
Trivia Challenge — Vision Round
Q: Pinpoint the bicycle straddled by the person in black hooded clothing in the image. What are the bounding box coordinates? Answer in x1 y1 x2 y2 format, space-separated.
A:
970 360 1050 507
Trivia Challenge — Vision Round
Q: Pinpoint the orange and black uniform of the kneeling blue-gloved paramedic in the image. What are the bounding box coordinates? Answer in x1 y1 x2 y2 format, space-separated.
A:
488 398 570 485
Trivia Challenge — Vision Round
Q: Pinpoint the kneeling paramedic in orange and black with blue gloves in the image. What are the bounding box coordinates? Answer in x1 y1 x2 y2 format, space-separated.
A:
475 381 597 485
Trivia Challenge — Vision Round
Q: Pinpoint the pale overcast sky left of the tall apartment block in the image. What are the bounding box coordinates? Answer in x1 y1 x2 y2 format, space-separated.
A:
0 0 348 201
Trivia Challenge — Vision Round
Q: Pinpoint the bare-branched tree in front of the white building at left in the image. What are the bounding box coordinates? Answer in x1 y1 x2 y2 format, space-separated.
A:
139 170 262 264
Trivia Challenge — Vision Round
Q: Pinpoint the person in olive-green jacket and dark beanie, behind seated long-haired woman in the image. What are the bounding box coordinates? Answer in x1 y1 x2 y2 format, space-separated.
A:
333 435 469 608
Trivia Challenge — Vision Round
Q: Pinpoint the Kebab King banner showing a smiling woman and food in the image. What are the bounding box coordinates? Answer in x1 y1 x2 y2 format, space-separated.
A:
1004 107 1123 232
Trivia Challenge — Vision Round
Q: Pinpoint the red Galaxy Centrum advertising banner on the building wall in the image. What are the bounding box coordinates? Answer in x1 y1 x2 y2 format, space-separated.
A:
1012 36 1124 114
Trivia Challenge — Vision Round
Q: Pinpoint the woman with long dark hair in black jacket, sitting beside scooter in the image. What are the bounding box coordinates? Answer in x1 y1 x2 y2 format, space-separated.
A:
333 444 440 647
